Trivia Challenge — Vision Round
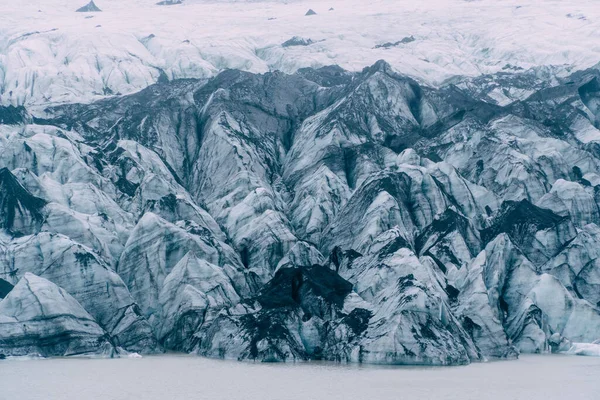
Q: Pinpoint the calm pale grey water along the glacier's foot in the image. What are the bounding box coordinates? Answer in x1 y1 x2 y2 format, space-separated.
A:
0 355 600 400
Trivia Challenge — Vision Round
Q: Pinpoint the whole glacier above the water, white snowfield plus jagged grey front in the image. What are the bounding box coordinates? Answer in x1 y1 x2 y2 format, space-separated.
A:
0 0 600 365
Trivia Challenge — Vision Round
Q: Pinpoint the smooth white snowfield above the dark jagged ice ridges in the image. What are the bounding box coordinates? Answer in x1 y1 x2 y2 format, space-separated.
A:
0 0 600 106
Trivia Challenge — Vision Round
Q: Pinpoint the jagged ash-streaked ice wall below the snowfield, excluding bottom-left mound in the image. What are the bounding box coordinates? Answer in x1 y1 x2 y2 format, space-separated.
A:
0 61 600 365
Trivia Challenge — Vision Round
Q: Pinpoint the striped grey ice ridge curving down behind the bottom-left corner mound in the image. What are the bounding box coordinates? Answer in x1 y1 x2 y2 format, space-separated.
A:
0 232 156 351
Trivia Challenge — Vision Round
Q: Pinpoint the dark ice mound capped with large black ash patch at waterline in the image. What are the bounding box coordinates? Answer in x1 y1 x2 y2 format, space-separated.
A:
193 265 354 361
